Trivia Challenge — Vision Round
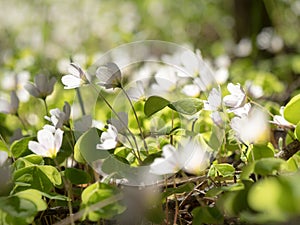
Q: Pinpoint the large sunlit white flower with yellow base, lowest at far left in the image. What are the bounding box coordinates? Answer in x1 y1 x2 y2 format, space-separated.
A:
28 126 64 158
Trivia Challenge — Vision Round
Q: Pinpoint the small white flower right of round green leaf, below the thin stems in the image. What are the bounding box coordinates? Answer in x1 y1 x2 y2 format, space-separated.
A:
96 124 118 150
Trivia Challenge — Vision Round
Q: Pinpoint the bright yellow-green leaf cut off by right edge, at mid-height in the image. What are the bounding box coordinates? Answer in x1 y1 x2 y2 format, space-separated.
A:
283 94 300 124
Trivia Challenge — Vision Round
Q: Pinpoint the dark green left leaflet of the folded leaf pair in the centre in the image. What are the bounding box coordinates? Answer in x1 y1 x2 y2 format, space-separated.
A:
144 96 170 117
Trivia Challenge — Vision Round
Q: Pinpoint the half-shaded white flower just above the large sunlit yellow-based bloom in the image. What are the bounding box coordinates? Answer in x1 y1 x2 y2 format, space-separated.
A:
44 102 71 128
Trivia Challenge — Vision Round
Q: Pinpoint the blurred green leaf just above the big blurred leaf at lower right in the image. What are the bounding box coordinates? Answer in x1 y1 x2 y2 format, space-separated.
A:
254 158 285 176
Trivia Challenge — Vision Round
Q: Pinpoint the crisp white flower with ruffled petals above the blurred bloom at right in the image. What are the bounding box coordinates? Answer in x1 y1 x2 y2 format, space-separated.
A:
223 83 246 108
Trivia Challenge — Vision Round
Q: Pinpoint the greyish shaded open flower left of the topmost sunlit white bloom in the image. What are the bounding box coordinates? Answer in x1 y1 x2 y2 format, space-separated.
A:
25 74 56 99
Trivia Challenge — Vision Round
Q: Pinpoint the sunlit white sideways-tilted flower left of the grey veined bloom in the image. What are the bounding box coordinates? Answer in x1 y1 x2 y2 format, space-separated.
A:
61 63 89 89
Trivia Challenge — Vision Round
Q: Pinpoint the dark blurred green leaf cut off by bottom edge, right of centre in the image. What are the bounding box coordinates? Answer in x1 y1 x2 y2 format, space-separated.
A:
192 206 224 225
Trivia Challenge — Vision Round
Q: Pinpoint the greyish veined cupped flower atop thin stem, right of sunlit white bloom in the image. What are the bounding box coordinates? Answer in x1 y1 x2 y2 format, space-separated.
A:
96 62 122 89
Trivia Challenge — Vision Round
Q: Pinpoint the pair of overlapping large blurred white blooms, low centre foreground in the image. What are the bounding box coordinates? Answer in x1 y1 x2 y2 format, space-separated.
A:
150 135 211 175
